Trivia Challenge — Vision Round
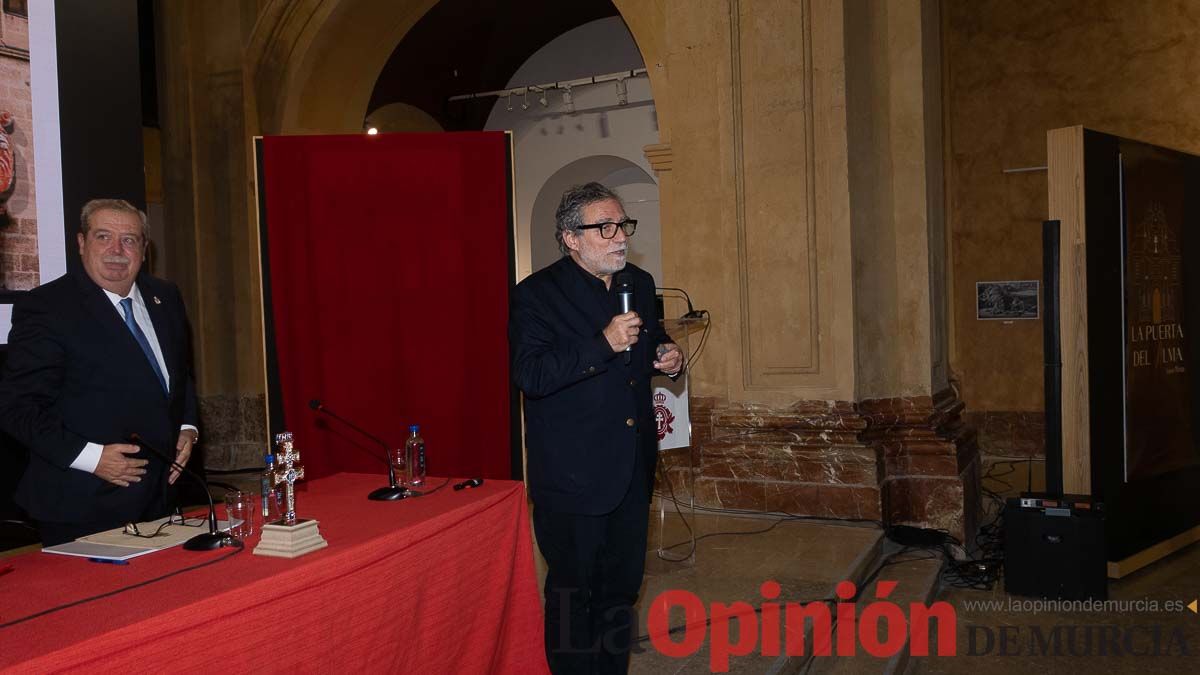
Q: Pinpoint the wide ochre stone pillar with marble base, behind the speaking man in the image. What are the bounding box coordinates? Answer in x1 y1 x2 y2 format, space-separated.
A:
648 0 978 537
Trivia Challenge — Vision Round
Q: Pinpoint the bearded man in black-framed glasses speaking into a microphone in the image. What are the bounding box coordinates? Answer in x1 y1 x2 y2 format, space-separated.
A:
509 183 683 674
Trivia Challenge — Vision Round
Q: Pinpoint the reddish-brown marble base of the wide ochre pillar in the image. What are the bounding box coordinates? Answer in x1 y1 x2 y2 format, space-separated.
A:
659 390 980 540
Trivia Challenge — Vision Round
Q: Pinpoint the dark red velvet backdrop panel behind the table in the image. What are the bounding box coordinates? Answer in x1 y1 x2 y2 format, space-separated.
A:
260 132 510 478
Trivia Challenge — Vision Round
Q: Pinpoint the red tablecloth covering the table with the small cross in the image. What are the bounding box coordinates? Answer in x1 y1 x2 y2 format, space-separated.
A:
0 473 546 674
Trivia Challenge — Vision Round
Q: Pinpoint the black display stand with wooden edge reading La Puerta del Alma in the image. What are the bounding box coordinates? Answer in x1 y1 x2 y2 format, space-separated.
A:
1045 127 1200 578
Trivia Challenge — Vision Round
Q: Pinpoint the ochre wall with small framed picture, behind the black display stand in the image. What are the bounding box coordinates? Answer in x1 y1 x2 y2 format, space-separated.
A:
942 0 1200 415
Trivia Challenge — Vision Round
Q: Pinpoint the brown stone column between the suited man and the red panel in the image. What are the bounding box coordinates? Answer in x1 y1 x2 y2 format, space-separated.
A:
155 0 268 468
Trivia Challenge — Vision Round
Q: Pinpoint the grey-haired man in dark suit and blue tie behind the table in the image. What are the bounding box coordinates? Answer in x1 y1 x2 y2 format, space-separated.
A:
0 199 199 545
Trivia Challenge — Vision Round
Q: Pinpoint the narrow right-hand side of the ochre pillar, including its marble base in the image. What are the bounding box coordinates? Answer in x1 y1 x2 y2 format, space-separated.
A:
846 0 979 538
